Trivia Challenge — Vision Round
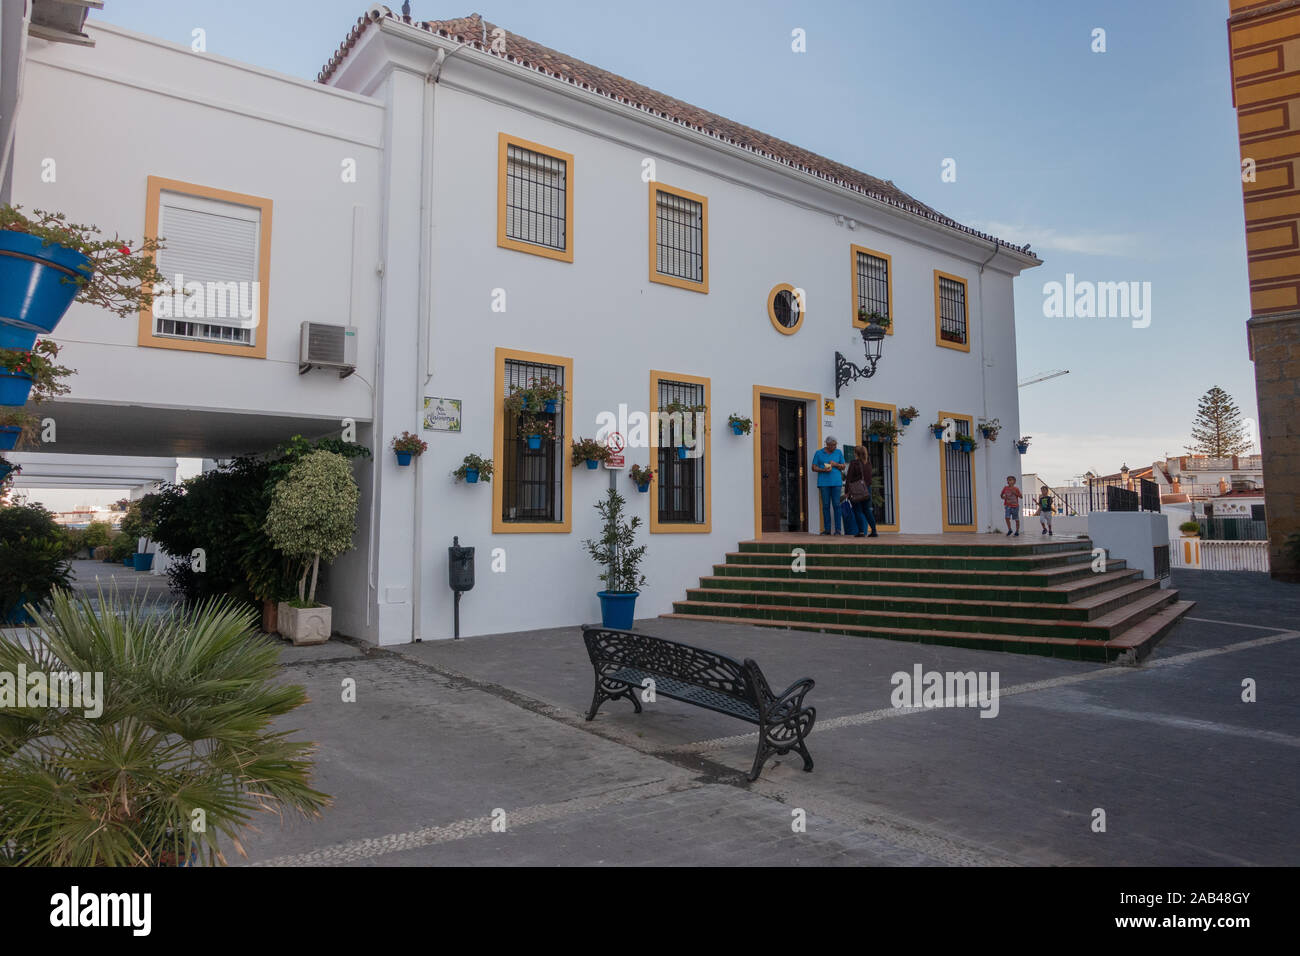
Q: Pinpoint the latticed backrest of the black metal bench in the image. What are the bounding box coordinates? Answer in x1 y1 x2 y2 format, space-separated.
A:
582 624 766 706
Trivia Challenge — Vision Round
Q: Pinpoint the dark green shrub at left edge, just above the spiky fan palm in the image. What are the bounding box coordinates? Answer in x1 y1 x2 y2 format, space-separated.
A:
0 505 72 624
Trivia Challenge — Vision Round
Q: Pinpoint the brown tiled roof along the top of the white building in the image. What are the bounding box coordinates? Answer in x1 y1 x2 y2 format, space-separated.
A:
316 5 1036 259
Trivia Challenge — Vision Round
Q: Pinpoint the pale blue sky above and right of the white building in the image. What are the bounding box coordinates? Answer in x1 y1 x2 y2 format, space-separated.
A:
96 0 1256 483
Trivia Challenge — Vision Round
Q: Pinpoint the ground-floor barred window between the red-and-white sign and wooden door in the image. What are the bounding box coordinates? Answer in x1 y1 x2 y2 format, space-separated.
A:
657 378 707 524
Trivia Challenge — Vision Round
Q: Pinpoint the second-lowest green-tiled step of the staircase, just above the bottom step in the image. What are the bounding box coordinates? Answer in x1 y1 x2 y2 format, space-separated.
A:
672 589 1178 641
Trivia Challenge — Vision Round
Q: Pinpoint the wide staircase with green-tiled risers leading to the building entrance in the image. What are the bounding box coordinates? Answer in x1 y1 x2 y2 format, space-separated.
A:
663 535 1195 662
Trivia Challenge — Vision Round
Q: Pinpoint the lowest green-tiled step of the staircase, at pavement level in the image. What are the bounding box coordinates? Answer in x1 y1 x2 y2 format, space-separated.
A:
663 601 1195 662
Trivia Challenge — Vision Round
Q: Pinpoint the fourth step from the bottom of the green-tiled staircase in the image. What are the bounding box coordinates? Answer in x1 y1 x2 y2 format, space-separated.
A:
699 568 1141 605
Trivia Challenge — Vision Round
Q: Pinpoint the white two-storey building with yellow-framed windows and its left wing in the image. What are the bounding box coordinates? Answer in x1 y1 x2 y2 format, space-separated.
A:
13 8 1039 644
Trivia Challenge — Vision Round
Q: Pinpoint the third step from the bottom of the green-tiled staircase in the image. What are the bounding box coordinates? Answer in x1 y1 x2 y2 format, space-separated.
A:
686 580 1160 630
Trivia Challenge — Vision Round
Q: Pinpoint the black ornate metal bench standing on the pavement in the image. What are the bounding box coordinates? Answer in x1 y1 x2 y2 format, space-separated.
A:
582 624 816 780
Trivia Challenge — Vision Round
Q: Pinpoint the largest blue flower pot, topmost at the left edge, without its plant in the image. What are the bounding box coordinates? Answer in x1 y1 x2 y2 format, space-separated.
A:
0 230 91 332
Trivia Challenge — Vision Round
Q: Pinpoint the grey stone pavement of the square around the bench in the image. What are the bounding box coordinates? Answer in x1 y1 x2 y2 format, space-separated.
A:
244 571 1300 865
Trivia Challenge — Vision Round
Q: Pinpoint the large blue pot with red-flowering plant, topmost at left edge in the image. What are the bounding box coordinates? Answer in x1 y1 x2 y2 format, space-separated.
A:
0 206 165 350
